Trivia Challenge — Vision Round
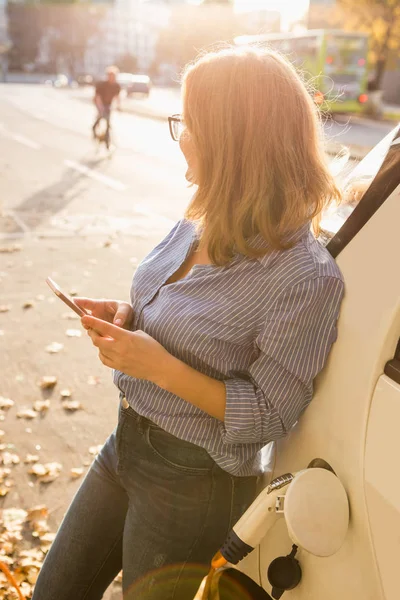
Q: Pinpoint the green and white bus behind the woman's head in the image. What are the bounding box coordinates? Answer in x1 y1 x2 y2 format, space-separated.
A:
234 29 368 113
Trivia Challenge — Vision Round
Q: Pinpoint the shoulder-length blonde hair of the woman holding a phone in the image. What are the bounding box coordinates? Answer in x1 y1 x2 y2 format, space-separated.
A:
183 47 340 265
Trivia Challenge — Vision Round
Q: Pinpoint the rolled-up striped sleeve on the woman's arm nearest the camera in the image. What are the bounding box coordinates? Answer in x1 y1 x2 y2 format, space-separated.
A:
221 276 344 444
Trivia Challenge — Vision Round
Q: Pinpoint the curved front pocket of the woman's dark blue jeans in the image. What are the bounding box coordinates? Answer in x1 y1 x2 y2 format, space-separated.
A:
146 425 215 475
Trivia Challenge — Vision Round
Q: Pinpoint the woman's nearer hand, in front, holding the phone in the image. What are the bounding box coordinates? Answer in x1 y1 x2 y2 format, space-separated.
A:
81 316 173 386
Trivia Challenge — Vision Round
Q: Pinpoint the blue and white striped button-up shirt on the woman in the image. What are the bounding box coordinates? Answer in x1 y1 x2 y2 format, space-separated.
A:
114 220 344 476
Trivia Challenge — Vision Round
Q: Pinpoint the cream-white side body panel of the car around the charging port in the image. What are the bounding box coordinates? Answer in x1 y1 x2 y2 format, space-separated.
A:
239 129 400 600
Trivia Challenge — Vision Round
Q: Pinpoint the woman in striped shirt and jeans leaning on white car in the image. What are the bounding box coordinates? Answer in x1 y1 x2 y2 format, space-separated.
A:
34 49 343 600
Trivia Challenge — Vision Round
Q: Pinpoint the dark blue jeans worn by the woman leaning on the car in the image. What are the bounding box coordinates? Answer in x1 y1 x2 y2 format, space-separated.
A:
32 405 256 600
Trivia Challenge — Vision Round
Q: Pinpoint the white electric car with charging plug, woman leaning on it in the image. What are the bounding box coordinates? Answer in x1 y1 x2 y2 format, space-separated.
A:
214 125 400 600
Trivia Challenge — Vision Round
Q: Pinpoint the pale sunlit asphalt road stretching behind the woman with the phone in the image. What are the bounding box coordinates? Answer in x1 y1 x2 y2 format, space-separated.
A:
0 85 391 599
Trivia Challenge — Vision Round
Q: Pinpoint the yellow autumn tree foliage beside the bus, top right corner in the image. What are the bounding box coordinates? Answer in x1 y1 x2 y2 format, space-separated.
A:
338 0 400 89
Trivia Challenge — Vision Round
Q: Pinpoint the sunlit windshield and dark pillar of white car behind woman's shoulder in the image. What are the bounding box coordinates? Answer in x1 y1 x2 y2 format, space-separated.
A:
319 125 400 256
